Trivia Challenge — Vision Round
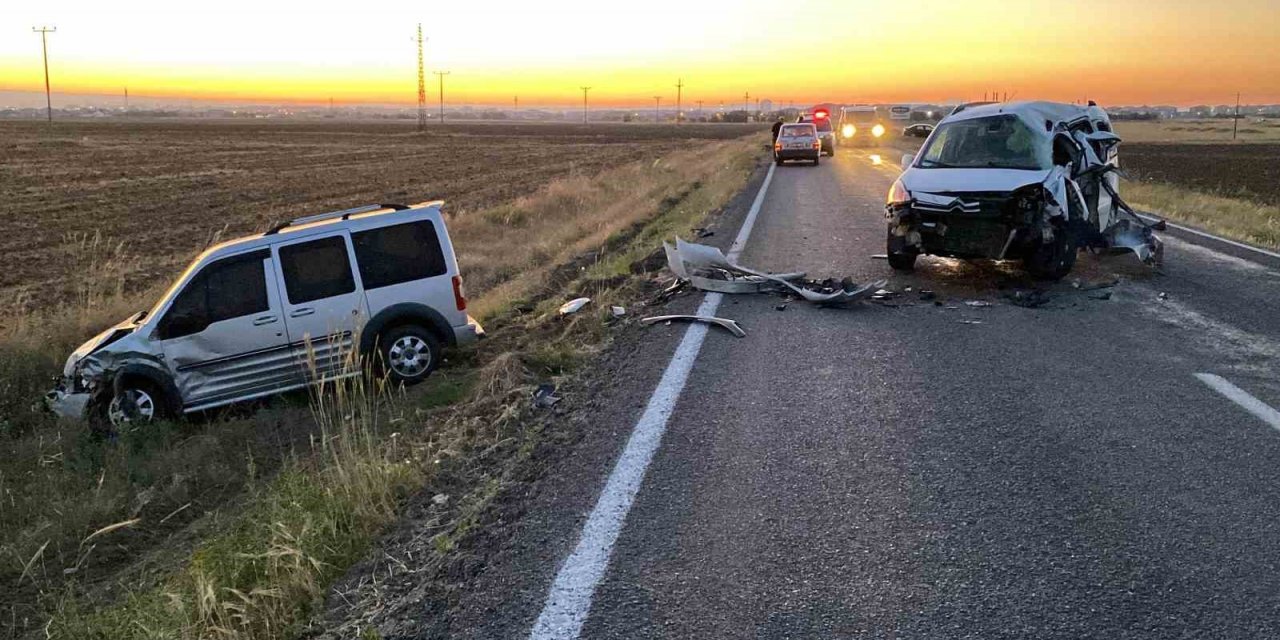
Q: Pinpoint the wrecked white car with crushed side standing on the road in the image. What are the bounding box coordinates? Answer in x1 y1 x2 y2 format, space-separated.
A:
886 102 1162 279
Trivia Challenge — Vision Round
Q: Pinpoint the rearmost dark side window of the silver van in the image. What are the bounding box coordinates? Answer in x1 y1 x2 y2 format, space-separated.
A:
351 220 447 291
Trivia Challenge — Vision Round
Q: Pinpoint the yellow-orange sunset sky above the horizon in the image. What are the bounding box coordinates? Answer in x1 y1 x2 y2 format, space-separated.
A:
0 0 1280 108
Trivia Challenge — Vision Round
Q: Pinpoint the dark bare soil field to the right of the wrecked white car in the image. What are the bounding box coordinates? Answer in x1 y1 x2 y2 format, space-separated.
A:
1120 142 1280 205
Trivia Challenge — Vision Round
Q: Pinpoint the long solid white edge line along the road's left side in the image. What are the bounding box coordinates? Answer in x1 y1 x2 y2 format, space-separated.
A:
529 164 776 640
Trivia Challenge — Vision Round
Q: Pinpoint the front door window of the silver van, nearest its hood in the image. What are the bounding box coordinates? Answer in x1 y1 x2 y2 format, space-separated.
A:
160 250 270 340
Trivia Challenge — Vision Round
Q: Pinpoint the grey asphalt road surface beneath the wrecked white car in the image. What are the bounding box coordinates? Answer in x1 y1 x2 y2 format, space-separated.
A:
435 138 1280 639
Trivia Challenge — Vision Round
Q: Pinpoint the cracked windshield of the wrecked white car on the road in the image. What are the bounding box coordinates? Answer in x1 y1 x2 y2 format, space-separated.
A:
916 114 1050 169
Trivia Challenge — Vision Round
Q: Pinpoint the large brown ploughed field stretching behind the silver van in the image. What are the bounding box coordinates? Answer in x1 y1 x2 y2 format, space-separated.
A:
0 120 749 312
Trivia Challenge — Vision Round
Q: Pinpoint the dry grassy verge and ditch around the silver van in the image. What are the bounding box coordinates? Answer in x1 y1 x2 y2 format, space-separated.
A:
0 132 758 639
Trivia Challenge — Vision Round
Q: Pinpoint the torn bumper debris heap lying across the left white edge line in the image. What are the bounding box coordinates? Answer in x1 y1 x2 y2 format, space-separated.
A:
662 238 886 306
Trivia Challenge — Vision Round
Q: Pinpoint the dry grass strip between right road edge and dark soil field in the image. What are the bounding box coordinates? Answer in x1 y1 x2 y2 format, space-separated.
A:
1123 182 1280 248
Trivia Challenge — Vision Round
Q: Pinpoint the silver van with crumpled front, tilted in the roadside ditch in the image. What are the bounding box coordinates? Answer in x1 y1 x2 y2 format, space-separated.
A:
46 201 484 426
